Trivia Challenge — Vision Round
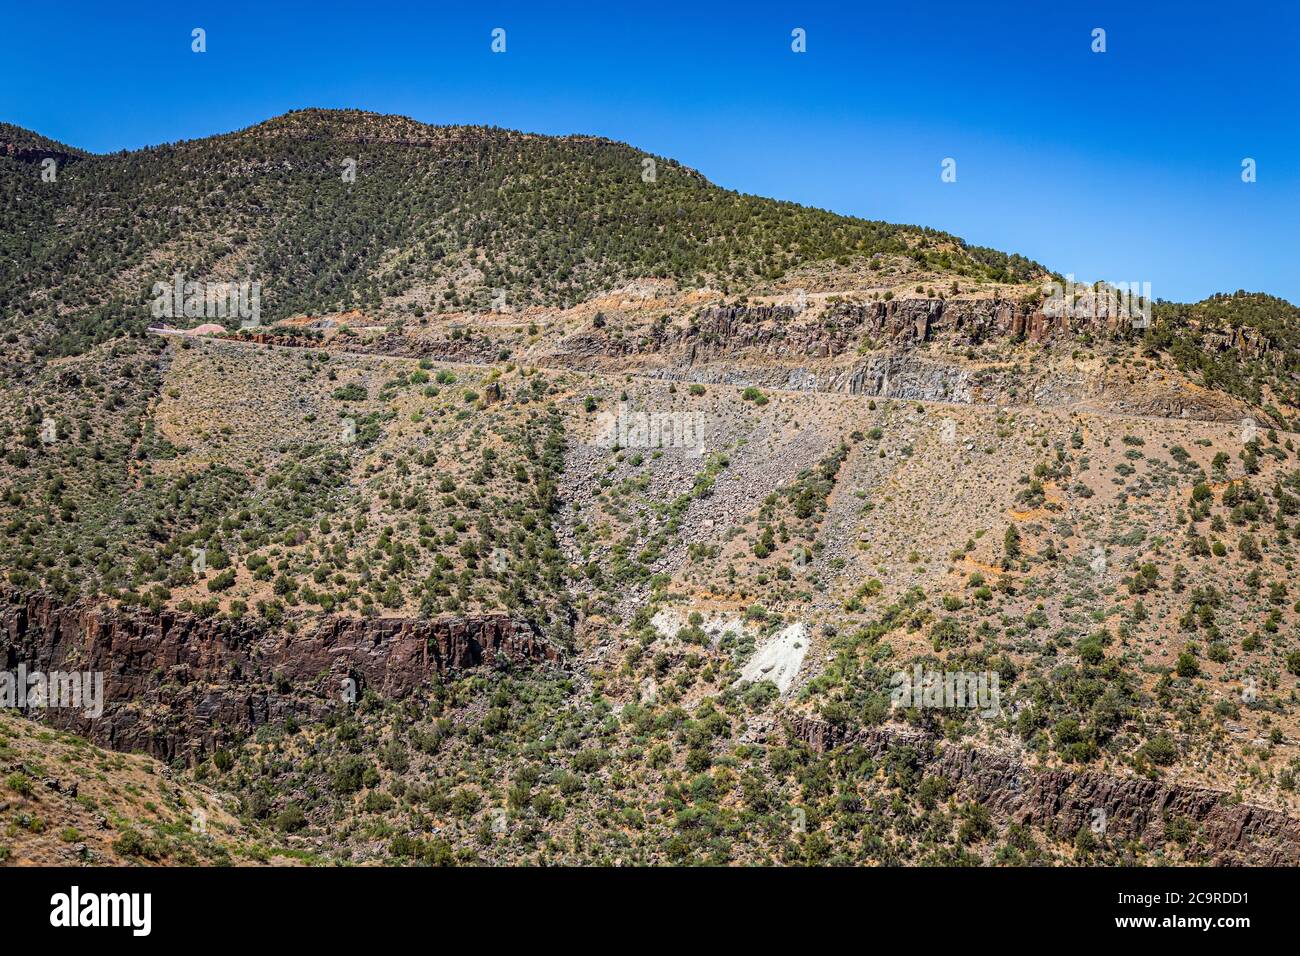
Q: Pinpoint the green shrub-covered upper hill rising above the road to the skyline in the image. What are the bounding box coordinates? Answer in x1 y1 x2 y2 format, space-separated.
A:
0 104 1040 354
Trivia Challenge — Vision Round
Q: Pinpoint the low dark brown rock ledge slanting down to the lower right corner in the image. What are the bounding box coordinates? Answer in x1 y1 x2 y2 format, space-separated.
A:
787 717 1300 866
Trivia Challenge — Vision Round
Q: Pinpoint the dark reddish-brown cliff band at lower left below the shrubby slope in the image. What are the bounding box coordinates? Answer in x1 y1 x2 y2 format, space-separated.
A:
0 592 559 760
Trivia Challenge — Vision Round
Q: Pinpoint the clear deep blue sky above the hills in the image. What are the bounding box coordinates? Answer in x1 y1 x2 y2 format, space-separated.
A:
0 0 1300 303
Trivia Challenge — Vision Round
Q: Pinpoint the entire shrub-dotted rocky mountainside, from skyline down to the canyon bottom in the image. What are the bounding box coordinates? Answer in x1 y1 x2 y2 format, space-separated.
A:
0 111 1300 865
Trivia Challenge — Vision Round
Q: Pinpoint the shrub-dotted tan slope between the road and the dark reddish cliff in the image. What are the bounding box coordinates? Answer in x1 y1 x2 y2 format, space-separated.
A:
0 339 569 640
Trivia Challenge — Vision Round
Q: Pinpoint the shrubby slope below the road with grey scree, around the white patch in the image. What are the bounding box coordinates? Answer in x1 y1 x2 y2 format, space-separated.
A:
149 381 1300 865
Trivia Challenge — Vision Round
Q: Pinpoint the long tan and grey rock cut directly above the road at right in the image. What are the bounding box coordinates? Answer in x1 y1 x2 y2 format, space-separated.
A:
537 299 1248 421
